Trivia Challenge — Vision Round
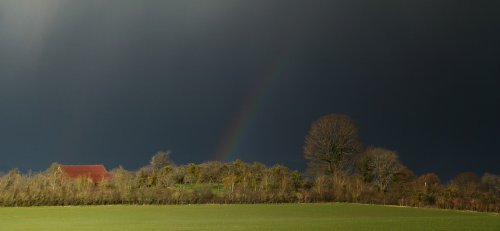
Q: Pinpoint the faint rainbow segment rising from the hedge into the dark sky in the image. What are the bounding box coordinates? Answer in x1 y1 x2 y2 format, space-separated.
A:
215 47 288 162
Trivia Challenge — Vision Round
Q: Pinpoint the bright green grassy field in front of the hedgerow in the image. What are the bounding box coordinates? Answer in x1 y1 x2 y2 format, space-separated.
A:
0 203 500 231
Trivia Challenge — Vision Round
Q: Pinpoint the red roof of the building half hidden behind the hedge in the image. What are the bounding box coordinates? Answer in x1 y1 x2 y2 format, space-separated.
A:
59 164 111 183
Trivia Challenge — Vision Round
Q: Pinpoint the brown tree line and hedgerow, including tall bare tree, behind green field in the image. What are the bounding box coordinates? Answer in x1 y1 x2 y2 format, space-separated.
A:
0 115 500 212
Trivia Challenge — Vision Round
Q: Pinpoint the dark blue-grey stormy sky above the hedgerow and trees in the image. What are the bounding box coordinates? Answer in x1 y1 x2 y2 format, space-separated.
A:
0 0 500 179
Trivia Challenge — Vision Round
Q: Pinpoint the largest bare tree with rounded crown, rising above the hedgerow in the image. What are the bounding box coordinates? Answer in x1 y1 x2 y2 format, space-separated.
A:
304 114 362 174
